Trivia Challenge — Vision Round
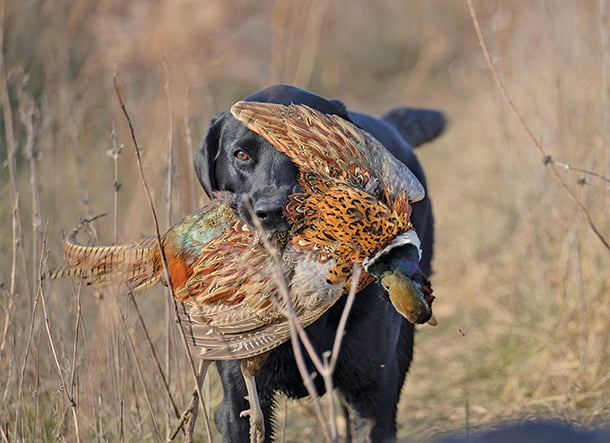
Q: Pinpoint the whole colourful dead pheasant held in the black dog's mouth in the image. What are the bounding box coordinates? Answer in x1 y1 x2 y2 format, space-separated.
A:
49 102 434 441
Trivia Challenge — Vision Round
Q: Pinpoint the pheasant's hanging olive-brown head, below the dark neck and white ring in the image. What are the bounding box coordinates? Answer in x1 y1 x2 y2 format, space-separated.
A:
379 271 438 326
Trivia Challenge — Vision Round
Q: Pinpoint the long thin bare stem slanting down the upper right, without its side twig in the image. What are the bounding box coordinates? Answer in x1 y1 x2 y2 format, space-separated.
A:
466 0 610 252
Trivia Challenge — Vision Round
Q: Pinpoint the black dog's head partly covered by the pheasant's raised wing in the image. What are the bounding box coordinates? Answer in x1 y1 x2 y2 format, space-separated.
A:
195 85 350 232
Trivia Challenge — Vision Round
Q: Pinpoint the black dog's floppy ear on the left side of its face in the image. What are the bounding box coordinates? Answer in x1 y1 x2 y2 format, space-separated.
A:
194 112 226 198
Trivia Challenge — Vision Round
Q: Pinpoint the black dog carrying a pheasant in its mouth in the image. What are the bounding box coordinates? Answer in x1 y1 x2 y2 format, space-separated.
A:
195 85 445 442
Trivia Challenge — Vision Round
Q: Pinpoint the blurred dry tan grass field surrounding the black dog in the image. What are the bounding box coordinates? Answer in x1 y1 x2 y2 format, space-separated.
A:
0 0 610 442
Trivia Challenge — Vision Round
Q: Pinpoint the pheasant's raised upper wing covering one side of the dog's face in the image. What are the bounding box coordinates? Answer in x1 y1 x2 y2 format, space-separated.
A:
231 101 425 202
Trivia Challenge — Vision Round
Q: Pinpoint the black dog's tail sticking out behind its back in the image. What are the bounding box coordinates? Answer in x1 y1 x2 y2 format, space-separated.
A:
381 107 447 148
